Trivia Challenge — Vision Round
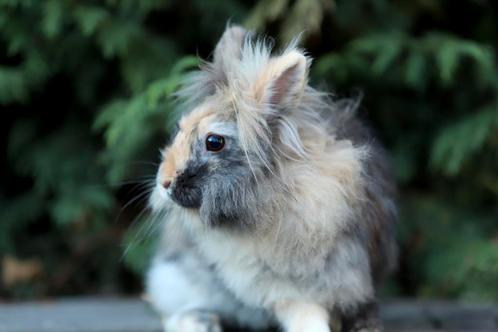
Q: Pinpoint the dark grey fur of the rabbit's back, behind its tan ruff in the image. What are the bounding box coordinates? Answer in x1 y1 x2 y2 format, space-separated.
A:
326 112 397 283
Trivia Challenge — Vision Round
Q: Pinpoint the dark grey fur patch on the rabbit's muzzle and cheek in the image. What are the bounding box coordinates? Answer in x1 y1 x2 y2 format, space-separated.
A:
171 132 267 229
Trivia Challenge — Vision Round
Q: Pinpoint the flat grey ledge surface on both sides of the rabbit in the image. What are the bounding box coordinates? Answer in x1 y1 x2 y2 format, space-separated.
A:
0 298 498 332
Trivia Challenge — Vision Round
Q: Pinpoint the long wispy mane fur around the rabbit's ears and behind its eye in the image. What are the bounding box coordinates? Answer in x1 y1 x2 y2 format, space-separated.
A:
176 33 357 178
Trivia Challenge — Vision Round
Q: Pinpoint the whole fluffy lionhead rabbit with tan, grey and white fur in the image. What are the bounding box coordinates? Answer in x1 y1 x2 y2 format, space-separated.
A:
146 26 396 332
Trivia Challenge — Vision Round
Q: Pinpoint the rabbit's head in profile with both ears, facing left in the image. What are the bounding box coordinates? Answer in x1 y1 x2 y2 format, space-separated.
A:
151 27 324 230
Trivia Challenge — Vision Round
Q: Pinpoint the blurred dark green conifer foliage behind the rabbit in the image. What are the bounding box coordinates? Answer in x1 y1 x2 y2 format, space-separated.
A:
0 0 498 300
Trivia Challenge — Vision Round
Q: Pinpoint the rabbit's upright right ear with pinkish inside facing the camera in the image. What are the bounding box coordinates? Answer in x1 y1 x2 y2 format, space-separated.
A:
255 50 309 109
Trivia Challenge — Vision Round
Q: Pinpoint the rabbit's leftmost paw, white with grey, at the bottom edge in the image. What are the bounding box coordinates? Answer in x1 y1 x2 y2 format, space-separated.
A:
164 310 222 332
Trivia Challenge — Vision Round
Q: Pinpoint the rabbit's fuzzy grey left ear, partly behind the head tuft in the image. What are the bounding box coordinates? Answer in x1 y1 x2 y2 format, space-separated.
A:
213 25 247 70
